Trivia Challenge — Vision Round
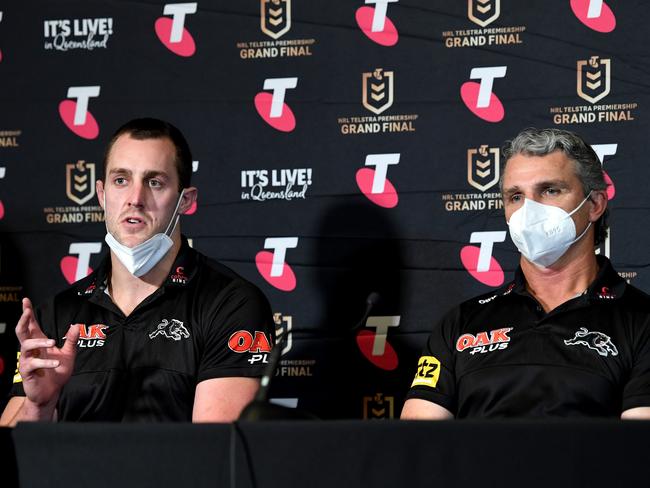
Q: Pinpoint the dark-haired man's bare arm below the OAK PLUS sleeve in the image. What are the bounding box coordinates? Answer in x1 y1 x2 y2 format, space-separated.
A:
192 378 260 422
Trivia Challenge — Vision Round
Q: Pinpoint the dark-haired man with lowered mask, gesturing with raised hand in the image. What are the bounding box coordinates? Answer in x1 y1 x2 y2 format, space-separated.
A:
1 119 272 425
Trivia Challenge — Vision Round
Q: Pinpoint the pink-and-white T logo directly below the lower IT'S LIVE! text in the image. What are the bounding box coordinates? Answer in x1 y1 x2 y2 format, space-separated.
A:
255 237 298 291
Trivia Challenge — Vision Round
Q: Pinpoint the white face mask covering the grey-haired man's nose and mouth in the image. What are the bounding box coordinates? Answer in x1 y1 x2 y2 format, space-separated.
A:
508 192 591 268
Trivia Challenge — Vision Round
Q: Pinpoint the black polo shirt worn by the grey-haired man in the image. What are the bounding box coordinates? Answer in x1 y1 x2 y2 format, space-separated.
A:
408 256 650 418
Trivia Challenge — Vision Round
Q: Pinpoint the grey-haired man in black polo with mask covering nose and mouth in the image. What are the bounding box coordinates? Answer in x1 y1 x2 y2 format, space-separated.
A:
402 128 650 419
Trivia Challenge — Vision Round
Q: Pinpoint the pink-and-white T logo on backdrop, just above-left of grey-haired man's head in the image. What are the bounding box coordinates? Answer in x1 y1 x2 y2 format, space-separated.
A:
460 66 508 122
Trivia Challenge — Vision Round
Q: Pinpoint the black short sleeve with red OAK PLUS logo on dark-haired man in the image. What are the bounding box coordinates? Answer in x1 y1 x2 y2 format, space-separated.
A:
197 280 274 382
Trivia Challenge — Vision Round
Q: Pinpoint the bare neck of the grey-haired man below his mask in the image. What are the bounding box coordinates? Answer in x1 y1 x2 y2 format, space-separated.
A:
520 236 598 312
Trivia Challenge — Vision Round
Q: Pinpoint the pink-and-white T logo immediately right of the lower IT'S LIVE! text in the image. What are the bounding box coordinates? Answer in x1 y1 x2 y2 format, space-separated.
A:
356 153 400 208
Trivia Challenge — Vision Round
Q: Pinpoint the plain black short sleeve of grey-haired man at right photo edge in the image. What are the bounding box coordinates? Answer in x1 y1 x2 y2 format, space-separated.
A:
623 315 650 411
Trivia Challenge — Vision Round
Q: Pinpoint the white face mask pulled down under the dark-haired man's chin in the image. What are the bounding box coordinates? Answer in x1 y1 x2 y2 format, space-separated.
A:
104 190 183 277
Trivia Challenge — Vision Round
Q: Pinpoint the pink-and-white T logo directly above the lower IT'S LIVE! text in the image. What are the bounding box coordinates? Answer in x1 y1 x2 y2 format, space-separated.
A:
254 77 298 132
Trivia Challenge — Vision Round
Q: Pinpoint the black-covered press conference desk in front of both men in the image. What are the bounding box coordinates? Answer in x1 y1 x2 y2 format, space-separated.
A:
0 421 650 488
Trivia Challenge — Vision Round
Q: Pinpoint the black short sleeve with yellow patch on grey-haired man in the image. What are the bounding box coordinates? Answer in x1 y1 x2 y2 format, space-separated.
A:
407 308 460 414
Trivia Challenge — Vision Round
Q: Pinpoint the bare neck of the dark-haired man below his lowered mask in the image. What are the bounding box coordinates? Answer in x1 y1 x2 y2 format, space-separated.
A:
108 229 181 316
